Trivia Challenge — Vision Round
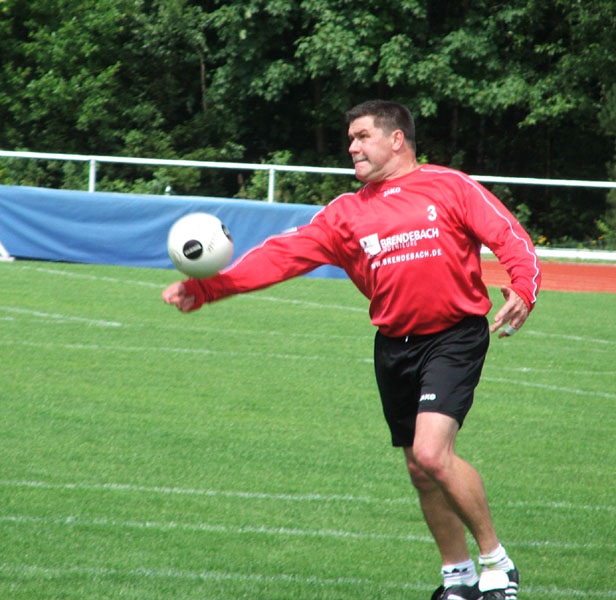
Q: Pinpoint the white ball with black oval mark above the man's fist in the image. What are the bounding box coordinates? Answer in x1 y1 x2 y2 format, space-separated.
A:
167 212 233 278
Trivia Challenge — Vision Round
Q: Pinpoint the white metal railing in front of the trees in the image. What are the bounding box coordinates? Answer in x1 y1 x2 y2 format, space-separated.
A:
0 150 616 261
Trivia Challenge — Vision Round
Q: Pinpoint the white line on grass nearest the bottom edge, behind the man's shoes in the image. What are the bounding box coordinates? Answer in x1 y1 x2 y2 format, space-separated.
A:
0 563 616 600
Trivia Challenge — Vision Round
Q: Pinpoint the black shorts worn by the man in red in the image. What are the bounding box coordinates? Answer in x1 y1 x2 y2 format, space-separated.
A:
374 317 490 446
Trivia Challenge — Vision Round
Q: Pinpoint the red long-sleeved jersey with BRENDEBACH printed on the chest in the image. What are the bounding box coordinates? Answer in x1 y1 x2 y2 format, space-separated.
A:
185 165 540 337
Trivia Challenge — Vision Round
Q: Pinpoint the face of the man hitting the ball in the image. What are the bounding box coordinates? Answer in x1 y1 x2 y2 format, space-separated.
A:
349 116 394 183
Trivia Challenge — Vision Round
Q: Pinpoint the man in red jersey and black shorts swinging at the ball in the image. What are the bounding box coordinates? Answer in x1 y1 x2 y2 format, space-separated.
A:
163 100 541 600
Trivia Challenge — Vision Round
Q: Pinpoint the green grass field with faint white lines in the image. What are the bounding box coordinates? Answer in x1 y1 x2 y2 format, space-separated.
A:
0 262 616 600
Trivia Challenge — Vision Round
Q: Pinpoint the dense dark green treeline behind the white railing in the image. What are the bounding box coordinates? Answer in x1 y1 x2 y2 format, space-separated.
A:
0 0 616 247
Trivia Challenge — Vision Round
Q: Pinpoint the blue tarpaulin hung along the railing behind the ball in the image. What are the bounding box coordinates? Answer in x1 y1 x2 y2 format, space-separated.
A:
0 186 346 277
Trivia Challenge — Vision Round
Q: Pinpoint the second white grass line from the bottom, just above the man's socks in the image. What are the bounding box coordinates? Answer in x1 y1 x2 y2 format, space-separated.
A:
0 515 616 552
